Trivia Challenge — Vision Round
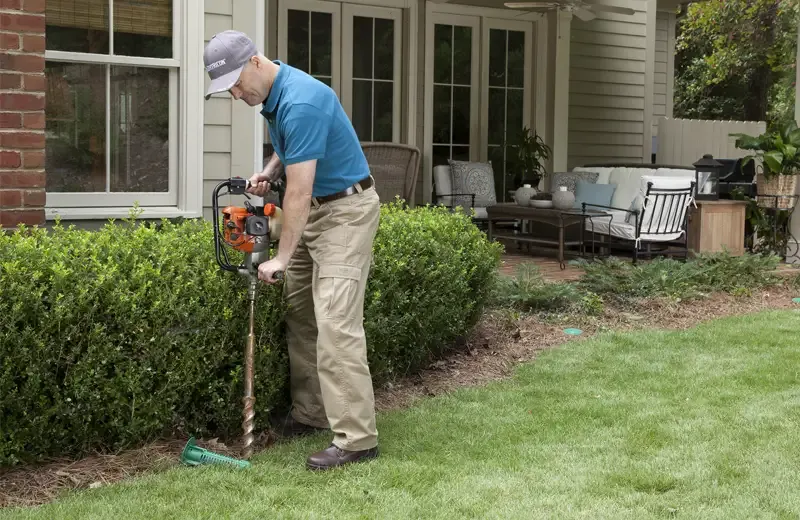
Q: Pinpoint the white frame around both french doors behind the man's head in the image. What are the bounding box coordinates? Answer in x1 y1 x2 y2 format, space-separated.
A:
272 0 421 145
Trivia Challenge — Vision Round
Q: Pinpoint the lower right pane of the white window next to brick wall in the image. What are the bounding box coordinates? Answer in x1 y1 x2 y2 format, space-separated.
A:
111 66 170 192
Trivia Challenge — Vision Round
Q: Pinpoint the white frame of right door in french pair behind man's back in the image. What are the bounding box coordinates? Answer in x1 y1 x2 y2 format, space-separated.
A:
341 4 403 142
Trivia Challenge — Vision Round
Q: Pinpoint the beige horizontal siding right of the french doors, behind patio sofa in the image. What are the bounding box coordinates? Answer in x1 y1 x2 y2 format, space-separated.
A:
567 0 652 168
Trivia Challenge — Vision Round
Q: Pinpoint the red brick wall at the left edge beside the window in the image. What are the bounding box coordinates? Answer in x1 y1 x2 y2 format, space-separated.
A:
0 0 45 228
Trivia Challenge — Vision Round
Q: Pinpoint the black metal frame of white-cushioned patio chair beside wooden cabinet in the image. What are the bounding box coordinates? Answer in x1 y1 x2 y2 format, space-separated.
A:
582 181 695 264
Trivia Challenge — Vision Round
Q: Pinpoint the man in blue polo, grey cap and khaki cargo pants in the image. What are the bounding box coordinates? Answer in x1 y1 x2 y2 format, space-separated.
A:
204 31 380 469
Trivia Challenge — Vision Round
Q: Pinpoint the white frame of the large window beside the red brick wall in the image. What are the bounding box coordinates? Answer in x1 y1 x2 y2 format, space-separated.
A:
45 0 204 219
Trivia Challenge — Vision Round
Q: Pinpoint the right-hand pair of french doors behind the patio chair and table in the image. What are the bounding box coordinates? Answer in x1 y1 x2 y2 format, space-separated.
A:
424 12 533 201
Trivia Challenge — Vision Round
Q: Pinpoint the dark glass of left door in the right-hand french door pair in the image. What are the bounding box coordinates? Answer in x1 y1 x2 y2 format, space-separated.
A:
433 24 472 162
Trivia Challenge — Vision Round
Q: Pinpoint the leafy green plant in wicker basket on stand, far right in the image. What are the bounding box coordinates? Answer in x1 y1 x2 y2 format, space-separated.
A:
731 121 800 209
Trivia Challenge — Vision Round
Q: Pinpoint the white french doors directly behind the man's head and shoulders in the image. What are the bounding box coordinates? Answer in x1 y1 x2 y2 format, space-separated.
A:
278 0 403 142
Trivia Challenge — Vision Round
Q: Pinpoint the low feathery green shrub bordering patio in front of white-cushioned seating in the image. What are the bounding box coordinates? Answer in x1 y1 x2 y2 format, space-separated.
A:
580 253 780 302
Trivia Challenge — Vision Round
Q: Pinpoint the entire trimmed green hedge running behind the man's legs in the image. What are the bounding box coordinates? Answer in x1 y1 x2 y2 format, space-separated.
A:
0 203 500 465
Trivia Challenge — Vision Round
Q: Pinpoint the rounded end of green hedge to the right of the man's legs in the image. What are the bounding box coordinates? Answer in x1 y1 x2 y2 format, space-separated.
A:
364 204 502 379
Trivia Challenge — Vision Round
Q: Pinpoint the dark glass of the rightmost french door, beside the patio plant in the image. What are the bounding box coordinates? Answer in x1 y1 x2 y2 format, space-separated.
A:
487 29 525 201
